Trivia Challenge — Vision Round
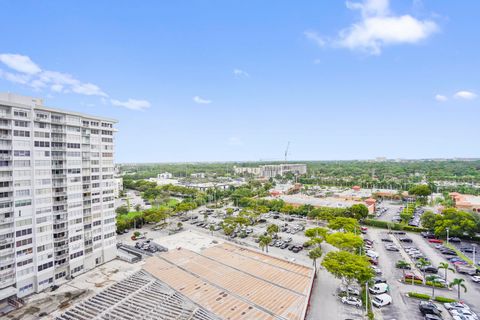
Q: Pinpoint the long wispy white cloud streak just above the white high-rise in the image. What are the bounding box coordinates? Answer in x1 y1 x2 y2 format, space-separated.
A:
0 53 150 110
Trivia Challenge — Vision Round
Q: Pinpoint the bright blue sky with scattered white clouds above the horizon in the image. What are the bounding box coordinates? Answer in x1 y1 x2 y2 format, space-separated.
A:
0 0 480 162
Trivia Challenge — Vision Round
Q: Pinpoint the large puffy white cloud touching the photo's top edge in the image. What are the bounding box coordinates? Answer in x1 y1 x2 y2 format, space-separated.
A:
305 0 439 55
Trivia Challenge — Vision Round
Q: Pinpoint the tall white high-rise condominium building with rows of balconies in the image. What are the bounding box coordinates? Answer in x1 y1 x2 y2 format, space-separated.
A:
0 94 116 308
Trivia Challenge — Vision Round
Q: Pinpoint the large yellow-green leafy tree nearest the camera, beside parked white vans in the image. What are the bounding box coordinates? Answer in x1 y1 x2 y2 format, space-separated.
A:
322 251 374 294
